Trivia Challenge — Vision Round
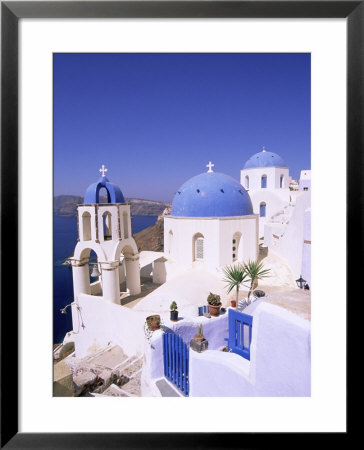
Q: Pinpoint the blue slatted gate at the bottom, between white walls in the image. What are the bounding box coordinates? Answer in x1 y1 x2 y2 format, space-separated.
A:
163 333 190 396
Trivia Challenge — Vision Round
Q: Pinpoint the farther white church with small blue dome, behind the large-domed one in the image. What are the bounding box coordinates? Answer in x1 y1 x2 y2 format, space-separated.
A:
240 147 290 237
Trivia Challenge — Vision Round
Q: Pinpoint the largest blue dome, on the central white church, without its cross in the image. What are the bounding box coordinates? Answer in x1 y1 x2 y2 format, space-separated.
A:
172 172 253 217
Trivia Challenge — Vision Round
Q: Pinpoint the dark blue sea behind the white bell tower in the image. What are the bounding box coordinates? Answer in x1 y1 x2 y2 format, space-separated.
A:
53 216 158 344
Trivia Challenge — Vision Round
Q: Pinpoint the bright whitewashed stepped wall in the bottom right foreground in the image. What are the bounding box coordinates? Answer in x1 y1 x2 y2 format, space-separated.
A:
190 303 311 397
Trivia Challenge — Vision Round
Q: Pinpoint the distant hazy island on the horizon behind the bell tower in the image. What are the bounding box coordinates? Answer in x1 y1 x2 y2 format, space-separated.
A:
53 195 171 217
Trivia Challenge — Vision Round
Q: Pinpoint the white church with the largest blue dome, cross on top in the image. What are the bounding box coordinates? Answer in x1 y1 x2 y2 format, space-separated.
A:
164 163 258 270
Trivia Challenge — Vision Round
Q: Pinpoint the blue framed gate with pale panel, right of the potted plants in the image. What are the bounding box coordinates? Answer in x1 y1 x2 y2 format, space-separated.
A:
225 309 253 360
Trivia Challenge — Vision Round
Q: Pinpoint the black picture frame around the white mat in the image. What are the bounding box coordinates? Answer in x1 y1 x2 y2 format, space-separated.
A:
0 0 358 449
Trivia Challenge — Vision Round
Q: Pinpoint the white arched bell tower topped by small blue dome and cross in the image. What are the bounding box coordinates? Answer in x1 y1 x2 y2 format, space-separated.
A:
70 165 141 304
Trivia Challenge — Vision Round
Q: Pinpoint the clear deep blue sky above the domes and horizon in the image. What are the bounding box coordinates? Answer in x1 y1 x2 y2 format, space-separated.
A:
53 53 311 201
